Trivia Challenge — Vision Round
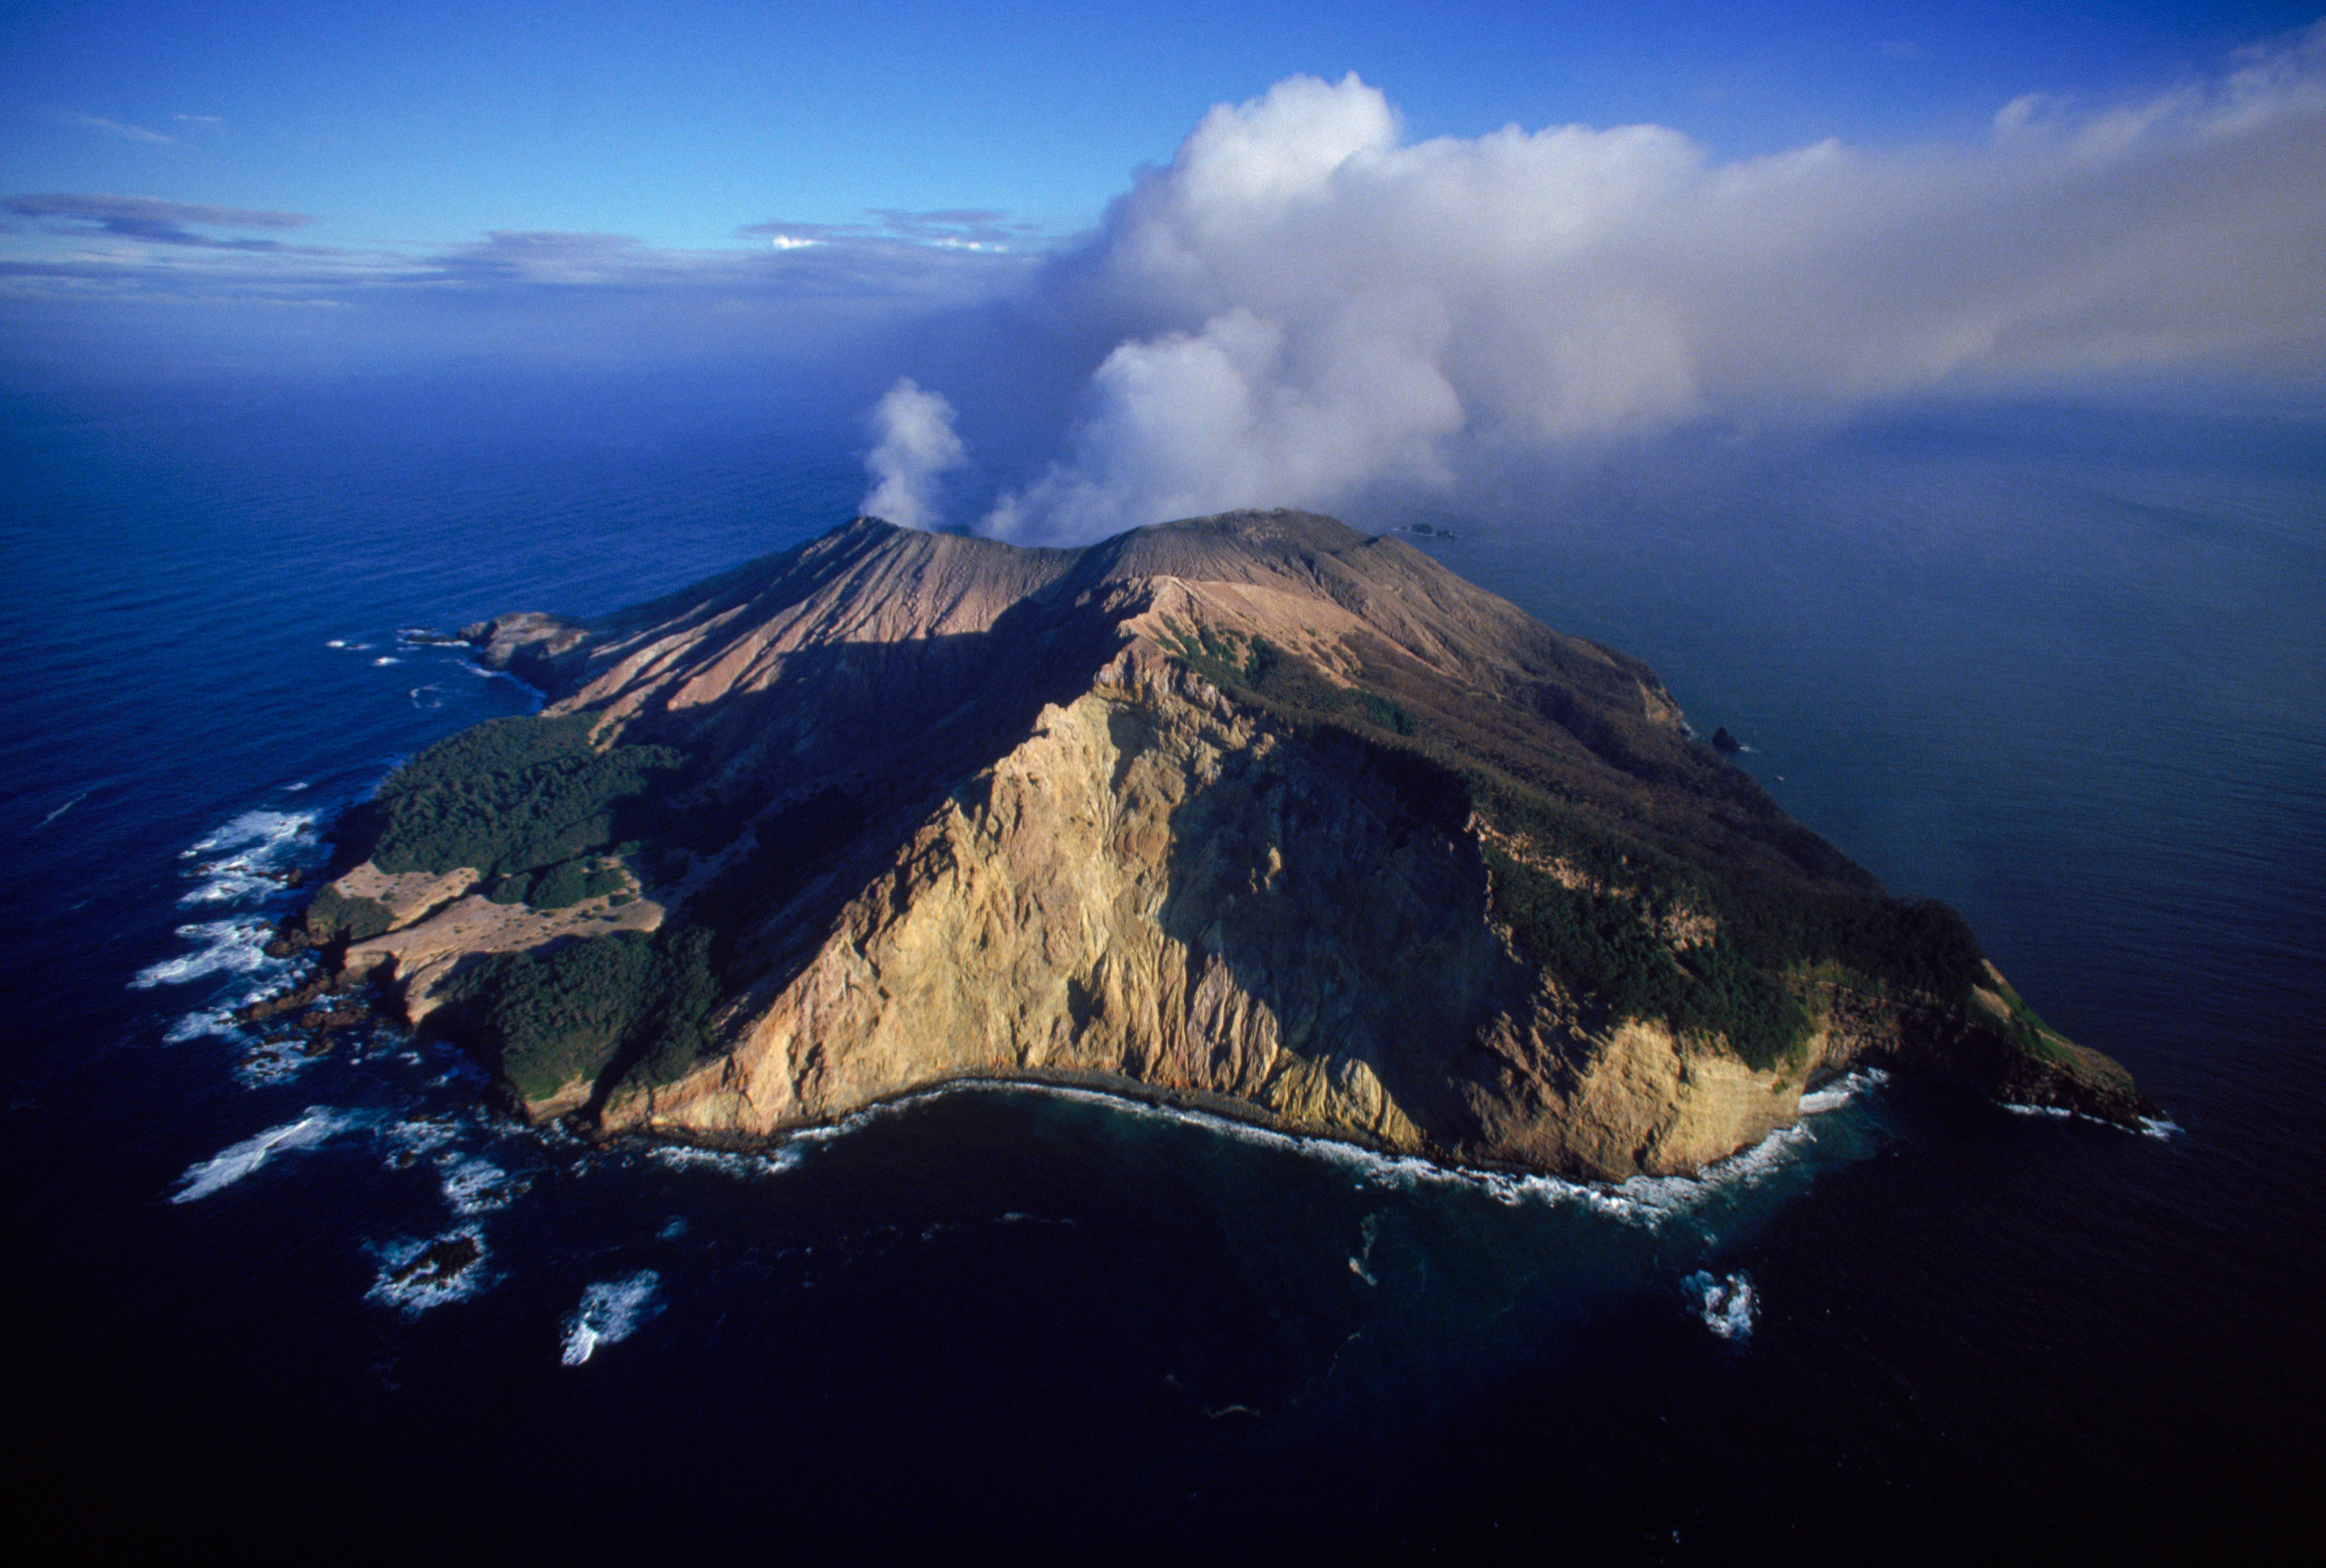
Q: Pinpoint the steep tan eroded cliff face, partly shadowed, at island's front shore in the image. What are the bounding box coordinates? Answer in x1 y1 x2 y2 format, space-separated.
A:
590 645 1891 1179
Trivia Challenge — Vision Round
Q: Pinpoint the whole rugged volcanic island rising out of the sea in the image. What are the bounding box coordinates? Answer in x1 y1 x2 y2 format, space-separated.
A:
286 512 2149 1179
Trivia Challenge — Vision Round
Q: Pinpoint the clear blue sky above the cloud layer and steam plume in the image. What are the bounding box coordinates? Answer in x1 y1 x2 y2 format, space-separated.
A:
0 0 2314 246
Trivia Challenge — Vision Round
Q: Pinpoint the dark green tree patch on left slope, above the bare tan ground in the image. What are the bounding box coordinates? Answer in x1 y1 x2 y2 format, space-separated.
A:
360 714 684 879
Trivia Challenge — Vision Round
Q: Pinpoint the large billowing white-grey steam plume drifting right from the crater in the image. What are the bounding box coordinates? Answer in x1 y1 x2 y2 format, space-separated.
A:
986 23 2326 537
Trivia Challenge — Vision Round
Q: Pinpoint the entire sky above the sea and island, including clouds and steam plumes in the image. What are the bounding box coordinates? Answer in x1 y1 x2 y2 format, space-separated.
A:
0 0 2326 537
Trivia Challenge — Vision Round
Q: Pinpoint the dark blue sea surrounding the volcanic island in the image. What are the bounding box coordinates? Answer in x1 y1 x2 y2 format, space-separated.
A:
0 382 2326 1561
